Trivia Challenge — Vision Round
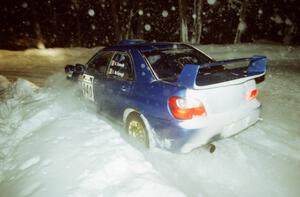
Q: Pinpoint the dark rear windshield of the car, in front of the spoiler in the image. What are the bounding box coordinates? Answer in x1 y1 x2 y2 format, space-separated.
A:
143 47 213 81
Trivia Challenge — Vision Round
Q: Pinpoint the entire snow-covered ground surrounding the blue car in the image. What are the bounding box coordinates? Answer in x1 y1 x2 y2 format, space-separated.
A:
0 45 300 197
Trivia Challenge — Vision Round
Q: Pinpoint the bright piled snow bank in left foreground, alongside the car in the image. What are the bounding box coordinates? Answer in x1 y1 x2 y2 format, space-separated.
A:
0 75 184 196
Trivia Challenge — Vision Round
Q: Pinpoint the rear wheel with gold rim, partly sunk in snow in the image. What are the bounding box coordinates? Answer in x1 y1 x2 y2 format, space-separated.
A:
126 113 149 148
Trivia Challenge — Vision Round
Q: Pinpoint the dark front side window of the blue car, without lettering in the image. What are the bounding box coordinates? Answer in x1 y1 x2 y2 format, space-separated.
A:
88 51 114 74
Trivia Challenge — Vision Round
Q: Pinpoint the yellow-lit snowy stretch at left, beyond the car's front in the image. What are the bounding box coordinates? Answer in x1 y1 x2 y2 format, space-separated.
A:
0 48 99 86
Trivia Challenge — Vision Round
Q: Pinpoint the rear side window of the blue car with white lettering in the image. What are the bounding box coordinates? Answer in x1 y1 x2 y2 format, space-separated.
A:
107 52 133 80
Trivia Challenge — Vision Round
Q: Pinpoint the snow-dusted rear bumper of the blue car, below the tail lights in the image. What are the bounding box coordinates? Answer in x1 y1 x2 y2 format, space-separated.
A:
148 100 260 153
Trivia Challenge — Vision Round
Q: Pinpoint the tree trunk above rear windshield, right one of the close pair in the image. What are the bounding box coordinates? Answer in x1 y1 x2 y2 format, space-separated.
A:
192 0 203 43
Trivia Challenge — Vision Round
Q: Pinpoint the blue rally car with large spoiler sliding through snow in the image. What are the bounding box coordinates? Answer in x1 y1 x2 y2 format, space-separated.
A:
65 40 267 152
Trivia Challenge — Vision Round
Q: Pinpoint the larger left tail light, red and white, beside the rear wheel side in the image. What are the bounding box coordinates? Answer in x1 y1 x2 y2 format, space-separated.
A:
169 96 206 120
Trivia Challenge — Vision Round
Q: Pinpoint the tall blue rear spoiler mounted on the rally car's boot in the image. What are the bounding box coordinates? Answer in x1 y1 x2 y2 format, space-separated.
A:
177 55 267 88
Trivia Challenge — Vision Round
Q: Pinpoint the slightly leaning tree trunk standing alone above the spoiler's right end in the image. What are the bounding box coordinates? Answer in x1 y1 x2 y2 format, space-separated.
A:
234 0 248 44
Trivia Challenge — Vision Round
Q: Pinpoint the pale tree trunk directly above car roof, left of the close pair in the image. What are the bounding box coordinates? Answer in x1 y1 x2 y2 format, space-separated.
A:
178 0 189 42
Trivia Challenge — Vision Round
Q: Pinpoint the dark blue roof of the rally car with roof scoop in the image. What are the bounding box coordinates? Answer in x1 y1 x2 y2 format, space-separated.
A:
103 40 187 52
